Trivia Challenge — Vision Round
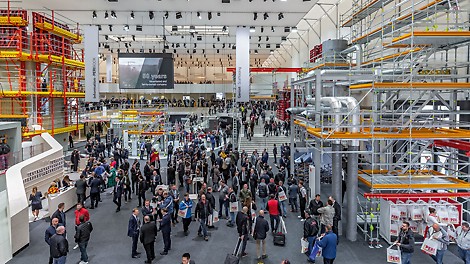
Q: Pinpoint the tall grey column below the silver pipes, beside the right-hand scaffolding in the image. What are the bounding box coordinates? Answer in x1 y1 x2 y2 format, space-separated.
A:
343 146 359 242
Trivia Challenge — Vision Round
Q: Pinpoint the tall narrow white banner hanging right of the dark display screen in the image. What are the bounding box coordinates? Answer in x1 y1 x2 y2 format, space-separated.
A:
235 27 250 103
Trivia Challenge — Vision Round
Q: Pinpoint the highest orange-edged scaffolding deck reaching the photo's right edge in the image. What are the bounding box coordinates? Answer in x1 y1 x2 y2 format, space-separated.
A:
392 31 470 47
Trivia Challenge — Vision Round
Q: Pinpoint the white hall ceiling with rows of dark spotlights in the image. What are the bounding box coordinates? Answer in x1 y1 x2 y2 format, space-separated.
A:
18 0 317 66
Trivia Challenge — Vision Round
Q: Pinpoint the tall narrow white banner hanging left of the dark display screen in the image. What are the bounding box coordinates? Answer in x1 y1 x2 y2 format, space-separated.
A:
83 26 100 102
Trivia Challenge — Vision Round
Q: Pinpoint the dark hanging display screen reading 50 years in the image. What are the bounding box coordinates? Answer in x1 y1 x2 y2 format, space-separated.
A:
119 53 174 89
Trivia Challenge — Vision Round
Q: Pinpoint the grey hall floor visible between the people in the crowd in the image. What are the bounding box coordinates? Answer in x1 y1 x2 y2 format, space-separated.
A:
8 122 463 264
